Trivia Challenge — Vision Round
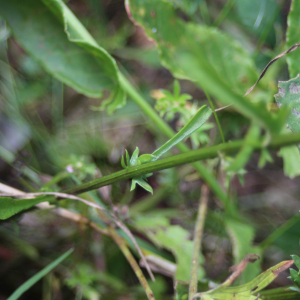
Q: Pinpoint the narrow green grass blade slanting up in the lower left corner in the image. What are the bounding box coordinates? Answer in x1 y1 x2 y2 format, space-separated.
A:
7 249 74 300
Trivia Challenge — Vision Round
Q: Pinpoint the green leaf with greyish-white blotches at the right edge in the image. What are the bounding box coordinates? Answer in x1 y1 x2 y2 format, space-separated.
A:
274 75 300 132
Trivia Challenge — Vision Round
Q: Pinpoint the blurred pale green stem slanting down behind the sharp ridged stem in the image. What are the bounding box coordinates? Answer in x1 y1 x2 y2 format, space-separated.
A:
119 73 228 206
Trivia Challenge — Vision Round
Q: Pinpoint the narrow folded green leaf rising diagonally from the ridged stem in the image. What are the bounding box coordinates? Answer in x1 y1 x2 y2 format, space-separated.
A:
152 105 212 161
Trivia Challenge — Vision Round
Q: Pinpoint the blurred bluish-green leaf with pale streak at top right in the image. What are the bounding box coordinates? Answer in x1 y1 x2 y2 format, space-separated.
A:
235 0 278 45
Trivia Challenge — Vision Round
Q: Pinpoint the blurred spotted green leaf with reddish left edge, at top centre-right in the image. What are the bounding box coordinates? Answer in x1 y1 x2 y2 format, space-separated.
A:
127 0 257 94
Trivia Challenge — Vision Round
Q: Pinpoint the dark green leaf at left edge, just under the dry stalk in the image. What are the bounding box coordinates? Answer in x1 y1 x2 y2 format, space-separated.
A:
0 196 53 220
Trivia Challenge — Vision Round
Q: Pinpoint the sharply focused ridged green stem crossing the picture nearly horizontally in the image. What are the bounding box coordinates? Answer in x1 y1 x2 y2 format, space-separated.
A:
63 133 300 196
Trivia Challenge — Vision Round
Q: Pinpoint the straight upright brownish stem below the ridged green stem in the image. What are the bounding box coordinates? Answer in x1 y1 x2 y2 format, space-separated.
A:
189 184 209 300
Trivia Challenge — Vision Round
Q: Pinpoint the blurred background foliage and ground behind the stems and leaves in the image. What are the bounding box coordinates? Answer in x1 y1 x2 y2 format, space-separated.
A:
0 0 300 300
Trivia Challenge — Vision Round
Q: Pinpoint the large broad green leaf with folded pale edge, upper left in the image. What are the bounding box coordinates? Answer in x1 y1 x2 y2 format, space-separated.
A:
0 0 125 112
